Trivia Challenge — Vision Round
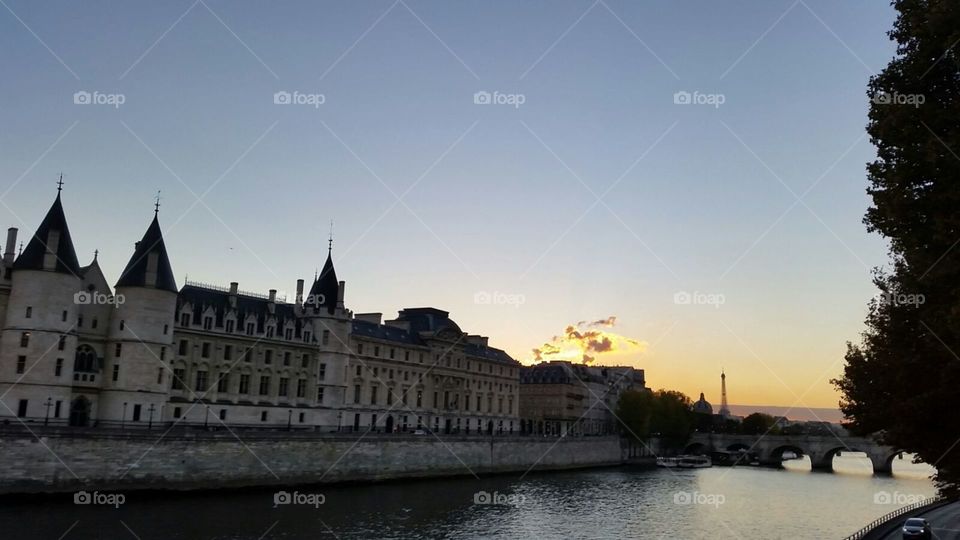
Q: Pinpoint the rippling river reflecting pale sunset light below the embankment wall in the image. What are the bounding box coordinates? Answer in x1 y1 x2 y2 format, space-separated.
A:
0 456 935 540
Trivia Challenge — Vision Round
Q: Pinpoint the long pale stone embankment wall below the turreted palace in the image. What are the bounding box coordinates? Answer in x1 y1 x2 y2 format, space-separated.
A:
0 428 623 495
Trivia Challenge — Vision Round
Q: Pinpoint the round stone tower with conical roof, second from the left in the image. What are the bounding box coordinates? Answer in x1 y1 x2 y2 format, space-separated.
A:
100 214 177 425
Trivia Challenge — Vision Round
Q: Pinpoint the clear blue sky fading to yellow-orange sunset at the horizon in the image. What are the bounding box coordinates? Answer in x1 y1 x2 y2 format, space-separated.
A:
0 0 894 412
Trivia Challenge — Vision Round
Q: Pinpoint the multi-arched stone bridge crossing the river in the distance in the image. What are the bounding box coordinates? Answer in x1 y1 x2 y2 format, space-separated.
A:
684 433 903 474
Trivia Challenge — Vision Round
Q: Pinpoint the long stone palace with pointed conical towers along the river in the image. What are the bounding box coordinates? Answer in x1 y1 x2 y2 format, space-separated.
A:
0 191 520 433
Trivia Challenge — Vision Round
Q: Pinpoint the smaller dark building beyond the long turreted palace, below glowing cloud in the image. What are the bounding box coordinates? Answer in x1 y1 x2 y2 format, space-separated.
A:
520 361 646 436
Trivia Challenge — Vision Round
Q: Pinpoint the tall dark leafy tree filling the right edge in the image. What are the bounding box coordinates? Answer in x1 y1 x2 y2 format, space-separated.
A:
833 0 960 495
